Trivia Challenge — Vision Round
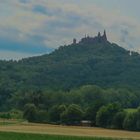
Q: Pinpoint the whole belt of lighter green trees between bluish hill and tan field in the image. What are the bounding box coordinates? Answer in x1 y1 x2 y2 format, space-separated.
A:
0 85 140 130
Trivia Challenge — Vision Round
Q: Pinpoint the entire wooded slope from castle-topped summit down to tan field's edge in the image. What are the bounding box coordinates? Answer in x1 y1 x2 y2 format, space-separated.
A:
0 32 140 130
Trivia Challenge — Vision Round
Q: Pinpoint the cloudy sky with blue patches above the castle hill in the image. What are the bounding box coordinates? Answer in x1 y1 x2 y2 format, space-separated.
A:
0 0 140 59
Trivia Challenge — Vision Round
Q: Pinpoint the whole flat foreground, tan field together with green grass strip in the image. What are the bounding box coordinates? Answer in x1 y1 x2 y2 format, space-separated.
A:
0 122 140 140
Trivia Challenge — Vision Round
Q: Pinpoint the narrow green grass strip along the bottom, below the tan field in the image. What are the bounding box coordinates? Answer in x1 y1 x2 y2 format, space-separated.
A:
0 132 130 140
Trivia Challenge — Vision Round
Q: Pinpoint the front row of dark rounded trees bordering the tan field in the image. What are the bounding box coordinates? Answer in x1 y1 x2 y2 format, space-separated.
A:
23 103 140 131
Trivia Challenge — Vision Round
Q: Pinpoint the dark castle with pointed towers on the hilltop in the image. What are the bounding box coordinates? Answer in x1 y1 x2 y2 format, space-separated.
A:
73 30 108 44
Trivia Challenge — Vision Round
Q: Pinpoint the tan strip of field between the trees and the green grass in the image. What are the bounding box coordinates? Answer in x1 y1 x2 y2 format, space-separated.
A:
0 122 140 140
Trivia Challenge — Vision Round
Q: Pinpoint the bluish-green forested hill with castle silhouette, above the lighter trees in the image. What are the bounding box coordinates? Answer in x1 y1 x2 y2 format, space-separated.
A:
0 32 140 91
